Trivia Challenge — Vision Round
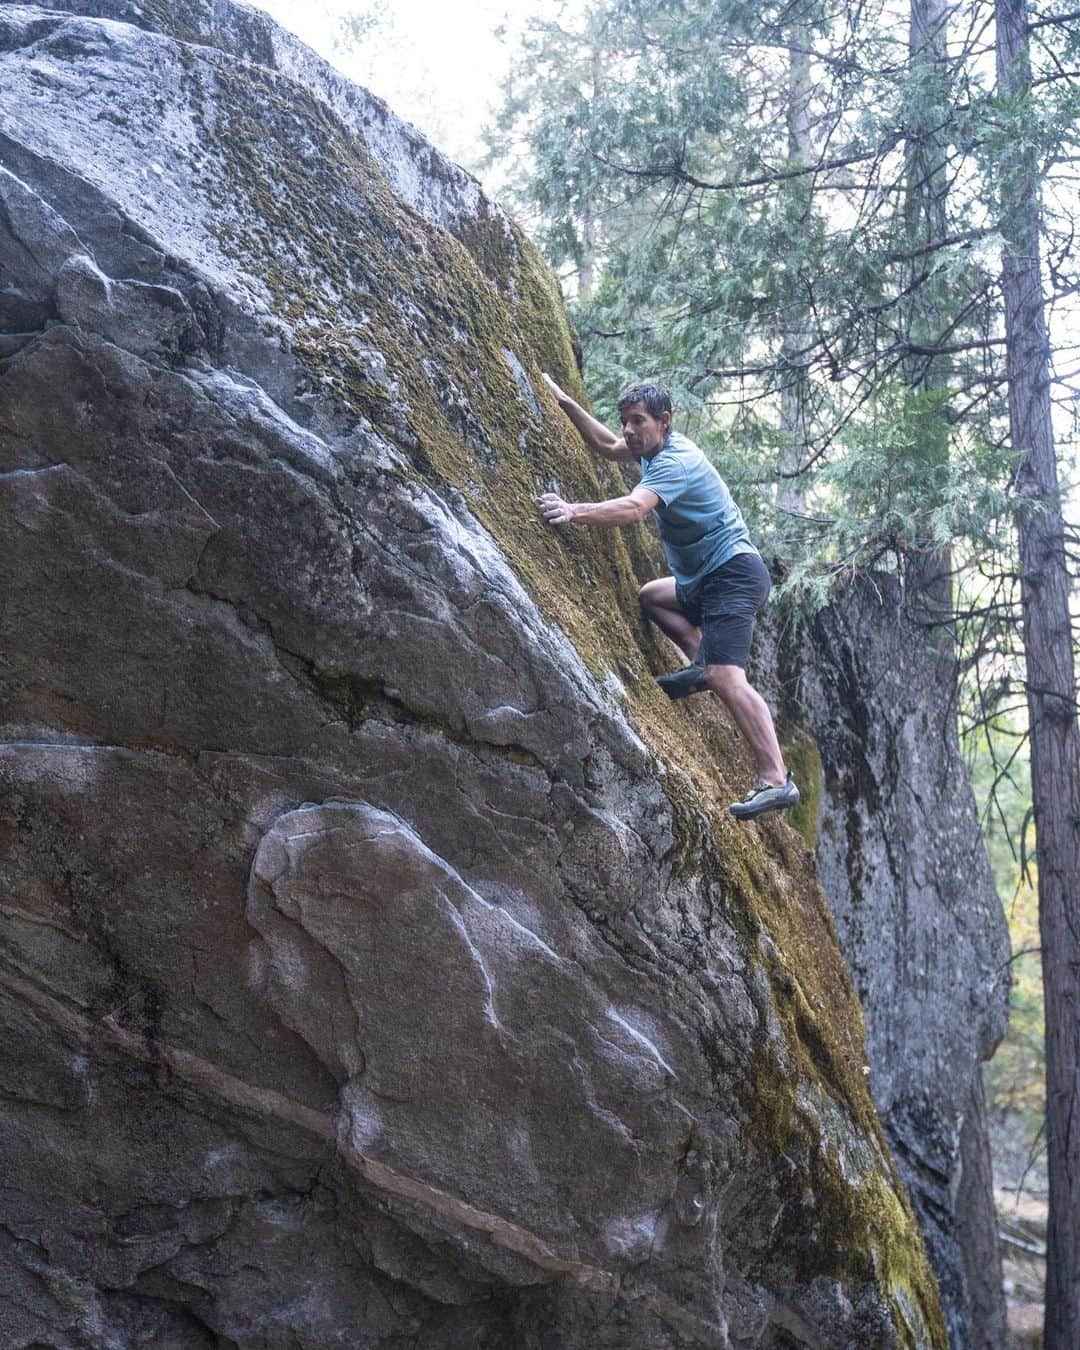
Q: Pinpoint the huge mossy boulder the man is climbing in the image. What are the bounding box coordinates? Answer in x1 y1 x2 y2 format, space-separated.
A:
0 0 945 1350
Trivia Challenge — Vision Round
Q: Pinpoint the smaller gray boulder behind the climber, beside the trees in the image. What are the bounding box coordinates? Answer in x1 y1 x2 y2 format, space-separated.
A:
761 574 1010 1346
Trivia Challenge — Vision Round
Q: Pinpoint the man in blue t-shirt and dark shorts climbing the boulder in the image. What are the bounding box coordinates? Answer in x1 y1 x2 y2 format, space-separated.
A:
537 374 799 819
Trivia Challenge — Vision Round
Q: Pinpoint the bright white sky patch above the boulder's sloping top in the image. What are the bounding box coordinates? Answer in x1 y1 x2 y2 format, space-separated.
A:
252 0 564 179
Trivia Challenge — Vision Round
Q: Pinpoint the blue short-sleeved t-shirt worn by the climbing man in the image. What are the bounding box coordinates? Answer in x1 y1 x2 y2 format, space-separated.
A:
640 431 757 586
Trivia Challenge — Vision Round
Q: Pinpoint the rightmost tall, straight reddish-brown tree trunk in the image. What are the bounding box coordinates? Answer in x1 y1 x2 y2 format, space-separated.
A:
996 0 1080 1350
